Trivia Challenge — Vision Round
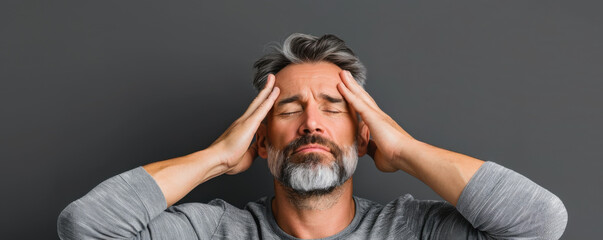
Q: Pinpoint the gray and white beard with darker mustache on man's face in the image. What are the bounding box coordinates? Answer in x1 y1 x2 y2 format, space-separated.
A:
267 142 358 196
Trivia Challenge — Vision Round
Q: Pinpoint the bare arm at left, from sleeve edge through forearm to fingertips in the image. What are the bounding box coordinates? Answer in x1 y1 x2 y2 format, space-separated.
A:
143 74 280 206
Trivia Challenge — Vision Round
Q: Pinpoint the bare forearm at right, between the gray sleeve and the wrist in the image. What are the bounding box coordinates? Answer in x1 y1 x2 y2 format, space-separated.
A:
397 138 484 206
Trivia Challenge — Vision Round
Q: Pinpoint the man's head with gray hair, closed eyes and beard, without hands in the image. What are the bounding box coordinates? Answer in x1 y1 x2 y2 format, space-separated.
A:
254 34 369 195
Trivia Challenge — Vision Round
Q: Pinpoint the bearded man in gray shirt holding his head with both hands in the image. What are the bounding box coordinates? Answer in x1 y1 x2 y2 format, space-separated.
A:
58 34 567 239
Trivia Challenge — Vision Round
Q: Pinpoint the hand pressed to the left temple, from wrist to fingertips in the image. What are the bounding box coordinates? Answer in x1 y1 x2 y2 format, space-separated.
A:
209 74 280 174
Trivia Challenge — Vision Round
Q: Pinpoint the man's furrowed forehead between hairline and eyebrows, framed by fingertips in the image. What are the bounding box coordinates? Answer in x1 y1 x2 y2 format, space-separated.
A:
275 62 342 98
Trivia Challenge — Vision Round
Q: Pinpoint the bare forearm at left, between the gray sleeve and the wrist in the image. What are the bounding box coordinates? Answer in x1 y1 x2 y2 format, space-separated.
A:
143 148 227 207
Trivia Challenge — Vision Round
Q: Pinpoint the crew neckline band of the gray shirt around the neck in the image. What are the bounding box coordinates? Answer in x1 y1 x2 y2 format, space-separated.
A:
265 196 362 240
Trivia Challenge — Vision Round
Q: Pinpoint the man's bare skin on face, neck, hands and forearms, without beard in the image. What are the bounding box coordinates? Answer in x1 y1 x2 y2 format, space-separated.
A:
144 62 483 238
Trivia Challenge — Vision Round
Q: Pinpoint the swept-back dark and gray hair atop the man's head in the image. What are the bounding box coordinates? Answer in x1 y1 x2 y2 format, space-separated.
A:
253 33 366 91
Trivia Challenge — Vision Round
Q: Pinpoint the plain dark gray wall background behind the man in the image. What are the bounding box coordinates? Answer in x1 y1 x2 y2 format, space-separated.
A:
0 1 603 239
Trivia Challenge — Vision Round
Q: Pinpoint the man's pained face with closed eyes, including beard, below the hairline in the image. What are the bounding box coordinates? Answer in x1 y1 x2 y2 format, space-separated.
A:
258 62 368 194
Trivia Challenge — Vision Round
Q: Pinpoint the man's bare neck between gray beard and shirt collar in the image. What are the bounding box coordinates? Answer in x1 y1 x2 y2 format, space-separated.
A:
272 178 355 238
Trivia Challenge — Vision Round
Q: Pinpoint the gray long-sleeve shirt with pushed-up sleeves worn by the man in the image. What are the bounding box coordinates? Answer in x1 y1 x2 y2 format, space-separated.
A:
58 162 567 239
